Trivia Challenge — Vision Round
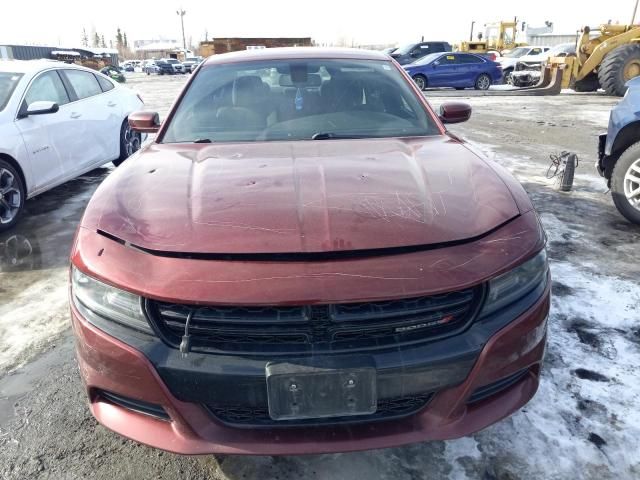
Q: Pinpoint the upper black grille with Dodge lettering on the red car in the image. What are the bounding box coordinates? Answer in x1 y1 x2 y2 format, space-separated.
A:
146 288 482 355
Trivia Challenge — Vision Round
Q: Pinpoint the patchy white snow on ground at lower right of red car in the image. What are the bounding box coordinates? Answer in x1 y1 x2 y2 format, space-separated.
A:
438 249 640 479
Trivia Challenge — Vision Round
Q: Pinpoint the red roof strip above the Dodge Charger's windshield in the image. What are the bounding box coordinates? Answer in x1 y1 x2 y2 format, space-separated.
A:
205 47 391 65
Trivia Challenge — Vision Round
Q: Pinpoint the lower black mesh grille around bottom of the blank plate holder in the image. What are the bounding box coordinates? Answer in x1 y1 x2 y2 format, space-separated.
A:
206 393 433 428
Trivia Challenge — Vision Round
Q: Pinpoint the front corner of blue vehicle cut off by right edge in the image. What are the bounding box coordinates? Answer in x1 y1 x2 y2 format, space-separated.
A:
596 77 640 225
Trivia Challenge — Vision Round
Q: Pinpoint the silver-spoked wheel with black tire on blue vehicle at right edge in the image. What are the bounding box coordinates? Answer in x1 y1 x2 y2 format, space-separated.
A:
611 142 640 225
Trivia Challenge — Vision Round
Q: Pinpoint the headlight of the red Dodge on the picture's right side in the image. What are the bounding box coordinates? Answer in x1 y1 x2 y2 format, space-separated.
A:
480 250 549 317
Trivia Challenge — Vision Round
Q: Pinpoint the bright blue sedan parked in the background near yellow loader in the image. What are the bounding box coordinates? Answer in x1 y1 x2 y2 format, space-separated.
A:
403 52 502 90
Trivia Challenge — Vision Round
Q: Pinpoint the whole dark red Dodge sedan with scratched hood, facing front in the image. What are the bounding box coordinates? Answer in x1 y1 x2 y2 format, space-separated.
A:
70 48 550 455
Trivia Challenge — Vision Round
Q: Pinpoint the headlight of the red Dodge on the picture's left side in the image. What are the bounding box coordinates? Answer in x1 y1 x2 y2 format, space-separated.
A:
71 267 153 333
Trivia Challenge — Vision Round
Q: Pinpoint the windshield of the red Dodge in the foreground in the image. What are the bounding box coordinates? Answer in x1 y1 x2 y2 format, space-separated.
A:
162 59 439 143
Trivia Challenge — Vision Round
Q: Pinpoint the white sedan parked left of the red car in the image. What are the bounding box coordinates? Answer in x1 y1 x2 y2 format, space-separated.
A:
0 60 144 231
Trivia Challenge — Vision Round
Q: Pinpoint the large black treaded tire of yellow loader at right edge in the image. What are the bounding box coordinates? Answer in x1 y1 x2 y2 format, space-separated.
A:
598 43 640 97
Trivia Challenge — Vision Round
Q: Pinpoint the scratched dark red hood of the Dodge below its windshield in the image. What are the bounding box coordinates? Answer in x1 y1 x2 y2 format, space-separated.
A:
90 136 519 253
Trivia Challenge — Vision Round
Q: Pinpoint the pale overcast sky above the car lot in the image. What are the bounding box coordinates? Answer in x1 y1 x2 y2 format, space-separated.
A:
0 0 640 47
